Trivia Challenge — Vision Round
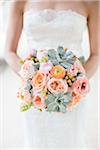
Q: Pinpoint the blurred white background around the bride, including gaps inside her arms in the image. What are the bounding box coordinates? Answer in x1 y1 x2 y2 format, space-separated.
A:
0 0 100 150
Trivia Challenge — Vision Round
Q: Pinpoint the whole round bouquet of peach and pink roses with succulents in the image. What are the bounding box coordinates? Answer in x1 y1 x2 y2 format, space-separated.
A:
18 46 89 113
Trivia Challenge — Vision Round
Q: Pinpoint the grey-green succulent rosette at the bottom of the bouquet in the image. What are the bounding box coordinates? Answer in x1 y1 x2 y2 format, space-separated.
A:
45 92 72 113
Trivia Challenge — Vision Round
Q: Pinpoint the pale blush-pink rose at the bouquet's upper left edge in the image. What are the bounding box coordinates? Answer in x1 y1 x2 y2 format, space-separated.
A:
19 60 35 80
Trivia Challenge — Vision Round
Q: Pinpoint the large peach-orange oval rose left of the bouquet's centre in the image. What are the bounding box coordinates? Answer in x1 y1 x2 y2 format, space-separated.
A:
32 71 47 91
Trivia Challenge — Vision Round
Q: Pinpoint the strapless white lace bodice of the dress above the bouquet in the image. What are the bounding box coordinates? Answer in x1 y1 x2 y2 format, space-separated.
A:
23 9 87 55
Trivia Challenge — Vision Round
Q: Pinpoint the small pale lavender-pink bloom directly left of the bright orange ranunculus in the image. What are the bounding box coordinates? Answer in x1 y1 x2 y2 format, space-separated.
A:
40 61 53 74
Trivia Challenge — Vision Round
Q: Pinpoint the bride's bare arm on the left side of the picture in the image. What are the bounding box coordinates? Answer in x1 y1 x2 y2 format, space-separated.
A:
5 2 25 74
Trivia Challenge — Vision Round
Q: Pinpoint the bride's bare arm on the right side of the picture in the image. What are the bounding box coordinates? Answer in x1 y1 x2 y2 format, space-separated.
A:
85 3 99 78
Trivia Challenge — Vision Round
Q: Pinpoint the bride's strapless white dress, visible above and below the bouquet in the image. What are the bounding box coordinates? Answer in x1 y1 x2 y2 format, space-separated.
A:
19 9 87 150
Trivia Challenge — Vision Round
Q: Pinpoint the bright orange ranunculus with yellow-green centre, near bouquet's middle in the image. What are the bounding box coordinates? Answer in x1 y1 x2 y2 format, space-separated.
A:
51 65 65 79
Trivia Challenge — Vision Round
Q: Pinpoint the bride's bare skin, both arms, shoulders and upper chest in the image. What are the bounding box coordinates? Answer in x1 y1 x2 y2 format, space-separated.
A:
5 0 99 78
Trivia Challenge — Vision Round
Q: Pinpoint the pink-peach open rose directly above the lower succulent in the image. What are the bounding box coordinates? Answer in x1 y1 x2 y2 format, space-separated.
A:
47 78 68 93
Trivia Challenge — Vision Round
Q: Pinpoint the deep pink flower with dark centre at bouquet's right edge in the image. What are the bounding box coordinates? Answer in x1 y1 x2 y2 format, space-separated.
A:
72 76 89 95
